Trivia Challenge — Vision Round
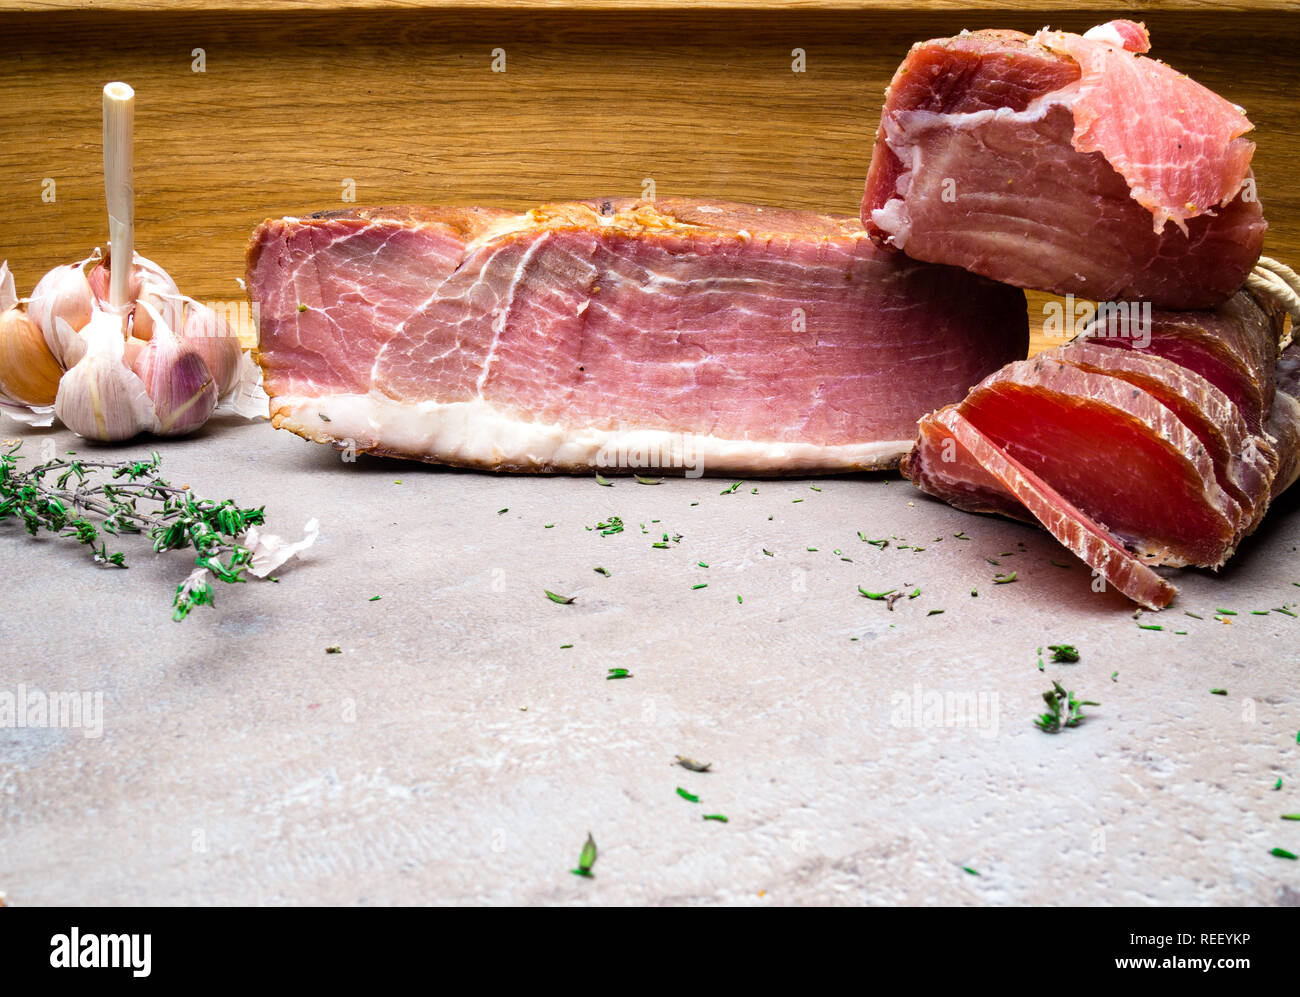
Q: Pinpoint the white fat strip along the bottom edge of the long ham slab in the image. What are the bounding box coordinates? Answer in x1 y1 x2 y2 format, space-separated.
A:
270 391 913 476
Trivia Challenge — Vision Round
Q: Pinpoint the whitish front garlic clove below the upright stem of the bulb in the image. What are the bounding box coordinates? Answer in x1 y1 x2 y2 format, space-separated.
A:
55 309 155 442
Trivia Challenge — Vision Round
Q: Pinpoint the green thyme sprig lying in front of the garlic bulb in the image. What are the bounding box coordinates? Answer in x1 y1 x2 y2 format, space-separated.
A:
0 443 265 620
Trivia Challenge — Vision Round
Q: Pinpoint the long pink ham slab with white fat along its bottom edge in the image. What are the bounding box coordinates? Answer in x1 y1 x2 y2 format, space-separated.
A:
248 200 1028 473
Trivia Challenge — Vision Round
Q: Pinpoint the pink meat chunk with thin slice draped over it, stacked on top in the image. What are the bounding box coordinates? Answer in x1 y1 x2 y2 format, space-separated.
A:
862 22 1266 308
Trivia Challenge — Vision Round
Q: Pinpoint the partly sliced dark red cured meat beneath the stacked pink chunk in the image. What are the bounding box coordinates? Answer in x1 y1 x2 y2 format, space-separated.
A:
901 291 1300 608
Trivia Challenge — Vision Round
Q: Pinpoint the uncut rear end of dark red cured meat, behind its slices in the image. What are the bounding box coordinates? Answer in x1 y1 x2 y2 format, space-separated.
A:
1084 291 1284 434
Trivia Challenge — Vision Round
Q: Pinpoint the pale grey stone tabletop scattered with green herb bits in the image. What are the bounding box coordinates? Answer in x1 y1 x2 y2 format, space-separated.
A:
0 420 1300 906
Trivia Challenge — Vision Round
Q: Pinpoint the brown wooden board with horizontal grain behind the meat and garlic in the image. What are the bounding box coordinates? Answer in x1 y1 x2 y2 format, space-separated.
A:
0 0 1300 350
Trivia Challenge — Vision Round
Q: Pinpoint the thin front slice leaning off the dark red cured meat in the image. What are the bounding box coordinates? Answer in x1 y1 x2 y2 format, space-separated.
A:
927 406 1177 610
